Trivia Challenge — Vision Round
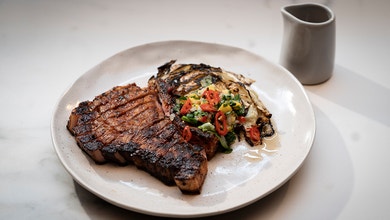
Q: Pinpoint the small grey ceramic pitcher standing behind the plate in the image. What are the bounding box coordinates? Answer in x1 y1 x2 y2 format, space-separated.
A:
280 3 336 84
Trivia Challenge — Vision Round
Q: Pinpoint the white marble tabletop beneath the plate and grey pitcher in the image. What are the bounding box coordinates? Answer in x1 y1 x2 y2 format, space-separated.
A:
0 0 390 219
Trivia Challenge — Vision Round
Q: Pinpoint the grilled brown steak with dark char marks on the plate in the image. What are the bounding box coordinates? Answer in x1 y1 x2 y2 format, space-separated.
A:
67 84 207 193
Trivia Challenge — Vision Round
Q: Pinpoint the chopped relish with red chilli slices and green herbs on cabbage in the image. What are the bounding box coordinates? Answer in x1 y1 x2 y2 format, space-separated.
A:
174 84 248 152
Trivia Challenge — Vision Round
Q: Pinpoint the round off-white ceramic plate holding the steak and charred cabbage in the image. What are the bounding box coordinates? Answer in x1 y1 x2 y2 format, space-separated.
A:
51 41 315 217
